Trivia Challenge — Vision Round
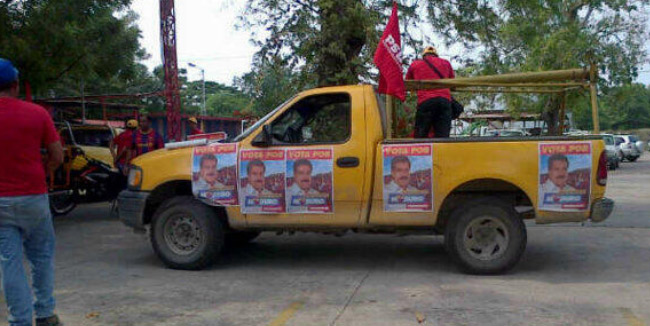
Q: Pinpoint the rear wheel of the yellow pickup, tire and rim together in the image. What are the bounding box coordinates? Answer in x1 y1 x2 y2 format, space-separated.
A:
445 197 527 275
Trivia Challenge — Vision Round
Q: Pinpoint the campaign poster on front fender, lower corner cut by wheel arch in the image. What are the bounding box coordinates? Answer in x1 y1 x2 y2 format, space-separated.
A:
192 143 238 206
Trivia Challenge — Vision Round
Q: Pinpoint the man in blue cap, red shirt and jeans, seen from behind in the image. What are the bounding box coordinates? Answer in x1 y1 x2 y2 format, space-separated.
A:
0 58 63 326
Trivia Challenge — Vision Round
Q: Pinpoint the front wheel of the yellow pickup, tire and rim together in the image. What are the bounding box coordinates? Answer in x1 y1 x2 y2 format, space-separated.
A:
150 196 225 270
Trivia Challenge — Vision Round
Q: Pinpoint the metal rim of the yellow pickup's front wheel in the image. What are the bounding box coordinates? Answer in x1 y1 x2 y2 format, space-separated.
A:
164 215 205 255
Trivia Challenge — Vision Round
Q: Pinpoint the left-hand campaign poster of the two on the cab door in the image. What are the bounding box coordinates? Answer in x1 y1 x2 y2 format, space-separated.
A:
239 149 285 214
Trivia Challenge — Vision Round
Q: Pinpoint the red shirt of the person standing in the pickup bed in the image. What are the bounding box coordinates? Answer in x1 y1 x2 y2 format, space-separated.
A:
406 55 456 104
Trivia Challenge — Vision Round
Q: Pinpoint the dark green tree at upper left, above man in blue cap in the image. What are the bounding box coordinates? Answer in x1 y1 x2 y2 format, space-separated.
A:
0 0 146 95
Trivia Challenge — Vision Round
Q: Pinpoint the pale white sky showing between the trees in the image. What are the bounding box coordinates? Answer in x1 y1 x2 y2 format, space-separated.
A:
131 0 650 85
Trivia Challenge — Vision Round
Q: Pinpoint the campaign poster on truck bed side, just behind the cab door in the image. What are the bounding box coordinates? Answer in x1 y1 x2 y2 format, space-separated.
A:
382 144 433 212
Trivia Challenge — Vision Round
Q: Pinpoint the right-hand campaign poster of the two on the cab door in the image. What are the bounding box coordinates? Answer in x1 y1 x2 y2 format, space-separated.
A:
286 148 334 214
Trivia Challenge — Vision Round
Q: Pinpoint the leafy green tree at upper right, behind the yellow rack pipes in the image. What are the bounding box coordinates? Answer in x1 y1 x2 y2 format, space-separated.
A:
427 0 648 132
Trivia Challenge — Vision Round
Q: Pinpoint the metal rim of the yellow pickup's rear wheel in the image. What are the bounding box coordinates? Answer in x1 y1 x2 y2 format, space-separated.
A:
463 216 510 260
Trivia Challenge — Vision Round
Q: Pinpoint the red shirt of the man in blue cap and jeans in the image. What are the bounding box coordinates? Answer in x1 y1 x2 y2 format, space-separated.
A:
0 97 59 197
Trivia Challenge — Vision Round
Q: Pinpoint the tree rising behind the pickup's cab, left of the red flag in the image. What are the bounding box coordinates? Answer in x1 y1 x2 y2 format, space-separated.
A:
241 0 421 86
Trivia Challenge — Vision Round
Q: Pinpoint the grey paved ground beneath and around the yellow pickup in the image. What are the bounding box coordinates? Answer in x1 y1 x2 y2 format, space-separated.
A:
0 155 650 326
